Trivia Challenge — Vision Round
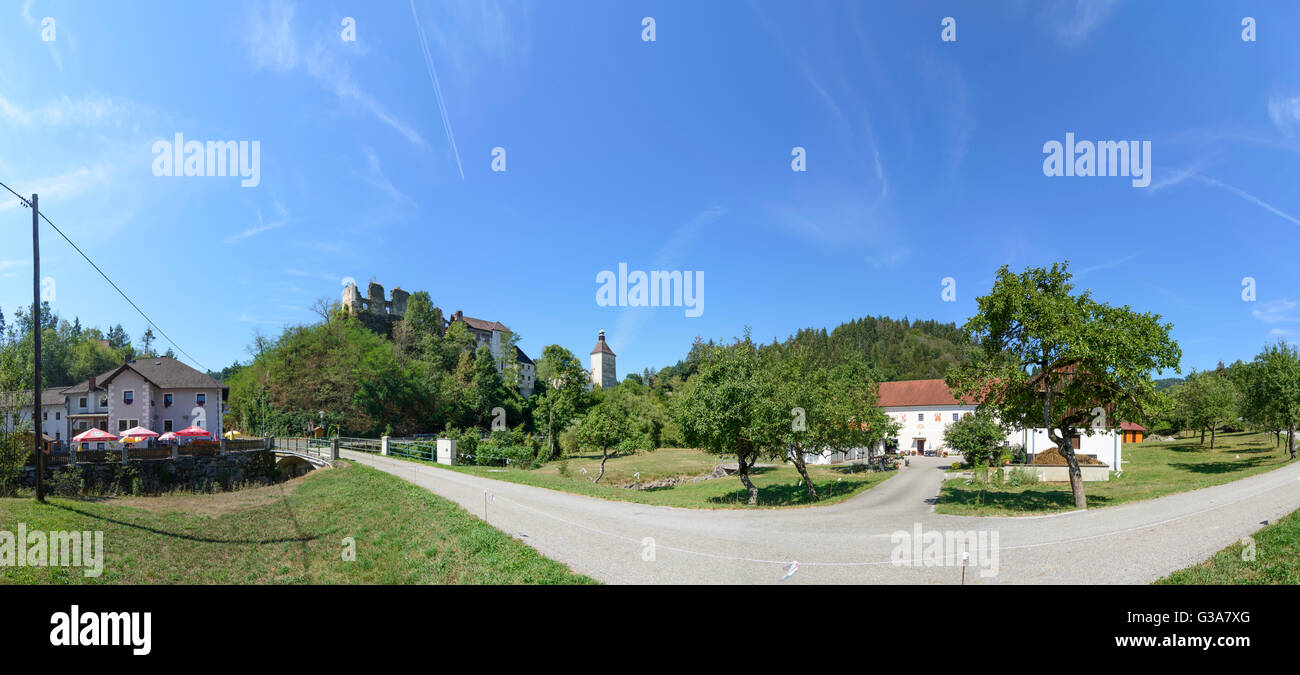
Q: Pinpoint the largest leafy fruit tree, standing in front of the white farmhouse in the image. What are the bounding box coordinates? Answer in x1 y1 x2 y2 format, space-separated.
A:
948 263 1182 509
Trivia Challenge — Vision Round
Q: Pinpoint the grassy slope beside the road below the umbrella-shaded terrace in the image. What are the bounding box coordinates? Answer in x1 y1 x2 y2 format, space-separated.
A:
0 463 594 584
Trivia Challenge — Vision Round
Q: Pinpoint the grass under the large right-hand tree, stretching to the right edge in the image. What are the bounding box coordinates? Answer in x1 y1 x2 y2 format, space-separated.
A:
935 432 1291 515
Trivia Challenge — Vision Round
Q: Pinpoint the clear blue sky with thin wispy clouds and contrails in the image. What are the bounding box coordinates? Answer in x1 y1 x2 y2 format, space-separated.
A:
0 0 1300 377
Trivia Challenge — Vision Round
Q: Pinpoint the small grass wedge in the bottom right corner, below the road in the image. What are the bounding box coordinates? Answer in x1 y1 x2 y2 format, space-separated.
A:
1156 511 1300 585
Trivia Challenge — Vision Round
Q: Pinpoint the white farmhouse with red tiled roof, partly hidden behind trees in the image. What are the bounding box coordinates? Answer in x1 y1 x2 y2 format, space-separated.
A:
806 380 1123 471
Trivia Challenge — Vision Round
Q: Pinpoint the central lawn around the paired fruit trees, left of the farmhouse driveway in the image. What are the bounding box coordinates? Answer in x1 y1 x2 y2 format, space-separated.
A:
395 447 897 509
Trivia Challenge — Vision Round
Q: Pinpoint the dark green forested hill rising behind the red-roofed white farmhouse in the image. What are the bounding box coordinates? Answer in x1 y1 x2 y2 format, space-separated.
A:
792 316 965 381
